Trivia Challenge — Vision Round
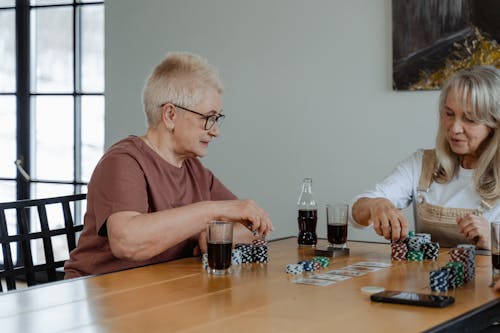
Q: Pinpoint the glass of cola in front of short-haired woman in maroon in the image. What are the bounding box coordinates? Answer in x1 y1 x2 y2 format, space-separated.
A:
207 221 234 275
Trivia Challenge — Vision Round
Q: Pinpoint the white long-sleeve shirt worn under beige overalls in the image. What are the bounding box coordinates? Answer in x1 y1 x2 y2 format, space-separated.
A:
351 149 500 228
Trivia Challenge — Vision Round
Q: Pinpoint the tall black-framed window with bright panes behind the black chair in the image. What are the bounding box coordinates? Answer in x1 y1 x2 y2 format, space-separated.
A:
0 0 104 265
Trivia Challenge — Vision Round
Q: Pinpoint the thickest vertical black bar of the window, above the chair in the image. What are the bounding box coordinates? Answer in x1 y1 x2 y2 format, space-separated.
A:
16 0 31 199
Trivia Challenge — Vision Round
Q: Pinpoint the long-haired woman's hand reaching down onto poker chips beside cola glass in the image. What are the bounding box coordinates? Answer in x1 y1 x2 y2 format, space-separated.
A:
370 200 408 241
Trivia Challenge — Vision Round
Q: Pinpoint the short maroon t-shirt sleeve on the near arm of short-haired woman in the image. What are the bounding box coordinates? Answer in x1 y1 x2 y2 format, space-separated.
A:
89 153 149 236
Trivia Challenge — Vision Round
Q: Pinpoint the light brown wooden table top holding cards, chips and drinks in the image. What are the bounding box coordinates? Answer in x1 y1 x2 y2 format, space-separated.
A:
0 238 500 333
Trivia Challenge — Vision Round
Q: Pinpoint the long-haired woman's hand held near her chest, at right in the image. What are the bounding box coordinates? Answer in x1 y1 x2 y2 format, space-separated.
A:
456 214 491 249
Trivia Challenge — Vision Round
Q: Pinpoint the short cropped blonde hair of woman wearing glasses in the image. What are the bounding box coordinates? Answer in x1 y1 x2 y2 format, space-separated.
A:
143 52 224 127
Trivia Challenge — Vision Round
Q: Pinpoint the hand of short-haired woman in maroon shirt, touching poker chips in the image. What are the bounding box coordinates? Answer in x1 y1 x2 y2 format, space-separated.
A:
214 200 274 237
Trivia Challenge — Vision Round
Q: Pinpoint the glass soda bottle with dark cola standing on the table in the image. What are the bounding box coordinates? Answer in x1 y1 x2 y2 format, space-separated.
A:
297 178 318 246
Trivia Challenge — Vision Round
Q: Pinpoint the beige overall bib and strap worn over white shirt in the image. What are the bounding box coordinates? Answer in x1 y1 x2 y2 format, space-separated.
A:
414 149 492 247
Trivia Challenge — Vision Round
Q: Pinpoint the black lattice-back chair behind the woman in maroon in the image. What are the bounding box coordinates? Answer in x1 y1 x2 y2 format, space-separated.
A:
0 194 87 292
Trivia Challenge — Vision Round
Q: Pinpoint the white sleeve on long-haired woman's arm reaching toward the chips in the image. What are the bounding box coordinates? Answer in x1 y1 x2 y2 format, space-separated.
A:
350 150 423 228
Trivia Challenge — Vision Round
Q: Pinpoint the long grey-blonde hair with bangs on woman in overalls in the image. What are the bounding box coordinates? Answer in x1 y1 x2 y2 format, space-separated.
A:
434 66 500 200
